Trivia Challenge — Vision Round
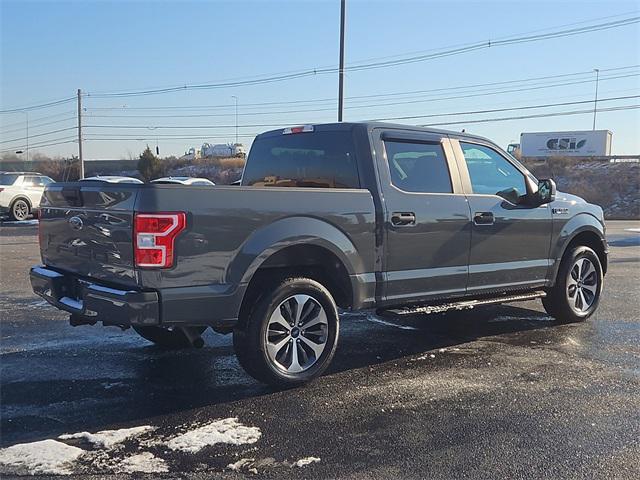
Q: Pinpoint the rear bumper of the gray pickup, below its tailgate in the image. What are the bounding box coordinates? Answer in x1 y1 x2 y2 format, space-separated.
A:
29 266 160 327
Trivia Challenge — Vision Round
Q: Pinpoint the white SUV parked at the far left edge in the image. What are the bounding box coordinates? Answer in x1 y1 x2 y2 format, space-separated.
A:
0 172 53 221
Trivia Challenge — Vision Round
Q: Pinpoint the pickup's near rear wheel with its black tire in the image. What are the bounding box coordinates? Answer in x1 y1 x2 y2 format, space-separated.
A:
233 277 339 387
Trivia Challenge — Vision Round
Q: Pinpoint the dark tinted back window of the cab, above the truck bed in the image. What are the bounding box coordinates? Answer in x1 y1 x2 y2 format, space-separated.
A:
242 131 360 188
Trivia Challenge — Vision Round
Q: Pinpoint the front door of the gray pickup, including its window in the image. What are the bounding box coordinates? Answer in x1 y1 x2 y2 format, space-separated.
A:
452 139 551 294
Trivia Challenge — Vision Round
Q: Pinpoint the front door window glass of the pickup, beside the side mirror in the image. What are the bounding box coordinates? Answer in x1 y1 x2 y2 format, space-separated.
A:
460 142 527 196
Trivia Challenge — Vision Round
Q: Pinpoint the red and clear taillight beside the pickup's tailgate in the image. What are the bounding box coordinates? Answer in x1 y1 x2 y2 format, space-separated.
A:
133 212 187 268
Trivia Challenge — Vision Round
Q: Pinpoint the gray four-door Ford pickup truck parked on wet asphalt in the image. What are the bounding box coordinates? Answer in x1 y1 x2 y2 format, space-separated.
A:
31 123 607 385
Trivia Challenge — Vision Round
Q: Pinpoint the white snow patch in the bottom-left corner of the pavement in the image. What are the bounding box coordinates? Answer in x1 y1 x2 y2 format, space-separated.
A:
0 439 85 475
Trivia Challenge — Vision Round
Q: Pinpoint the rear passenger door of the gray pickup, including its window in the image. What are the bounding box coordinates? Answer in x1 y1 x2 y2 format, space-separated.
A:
372 129 471 305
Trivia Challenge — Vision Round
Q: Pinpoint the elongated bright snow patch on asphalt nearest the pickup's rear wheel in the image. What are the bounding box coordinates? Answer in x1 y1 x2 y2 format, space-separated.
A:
167 418 262 453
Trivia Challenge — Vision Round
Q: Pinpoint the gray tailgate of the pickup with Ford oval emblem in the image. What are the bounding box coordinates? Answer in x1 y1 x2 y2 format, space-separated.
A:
39 182 139 286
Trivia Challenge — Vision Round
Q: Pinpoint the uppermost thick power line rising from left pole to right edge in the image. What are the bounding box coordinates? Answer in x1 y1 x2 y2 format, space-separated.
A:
82 17 640 98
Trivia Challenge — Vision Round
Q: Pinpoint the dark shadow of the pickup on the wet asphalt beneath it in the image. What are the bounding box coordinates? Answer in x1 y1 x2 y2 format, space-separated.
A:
1 306 555 446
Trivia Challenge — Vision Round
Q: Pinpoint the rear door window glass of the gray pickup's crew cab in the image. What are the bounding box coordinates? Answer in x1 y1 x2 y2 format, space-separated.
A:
384 141 453 193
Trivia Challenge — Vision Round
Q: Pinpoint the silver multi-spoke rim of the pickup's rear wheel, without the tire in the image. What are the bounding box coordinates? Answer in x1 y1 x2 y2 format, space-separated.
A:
265 294 329 373
